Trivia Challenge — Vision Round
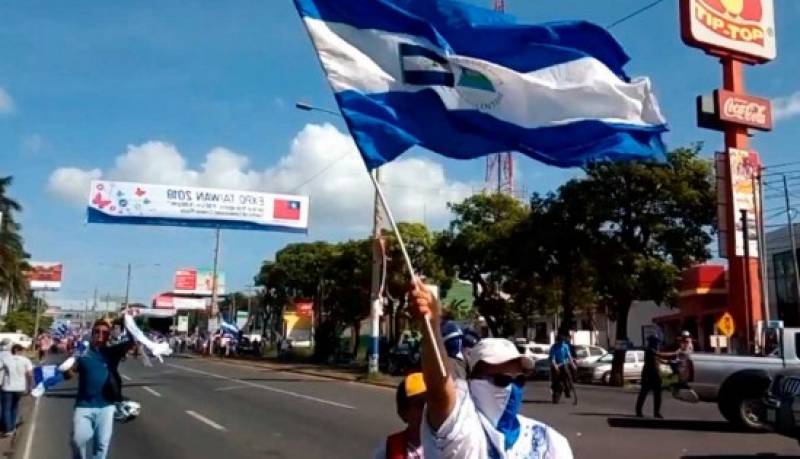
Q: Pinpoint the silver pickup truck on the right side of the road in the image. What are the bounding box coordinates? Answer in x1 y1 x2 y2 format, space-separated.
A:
689 328 800 430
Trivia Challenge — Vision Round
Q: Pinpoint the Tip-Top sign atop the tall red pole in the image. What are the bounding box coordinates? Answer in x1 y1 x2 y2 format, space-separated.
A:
680 0 777 63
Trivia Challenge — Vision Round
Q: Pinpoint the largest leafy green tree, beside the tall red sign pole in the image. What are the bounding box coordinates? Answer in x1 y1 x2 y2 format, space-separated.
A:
576 146 716 384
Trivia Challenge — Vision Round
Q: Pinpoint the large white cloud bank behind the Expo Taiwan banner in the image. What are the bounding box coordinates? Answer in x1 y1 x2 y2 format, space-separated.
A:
49 124 473 230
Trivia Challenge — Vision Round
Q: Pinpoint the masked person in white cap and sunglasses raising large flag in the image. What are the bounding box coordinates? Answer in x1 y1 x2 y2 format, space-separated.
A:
409 279 573 459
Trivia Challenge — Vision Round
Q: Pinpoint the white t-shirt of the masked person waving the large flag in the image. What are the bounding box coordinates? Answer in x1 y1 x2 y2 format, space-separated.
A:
422 380 572 459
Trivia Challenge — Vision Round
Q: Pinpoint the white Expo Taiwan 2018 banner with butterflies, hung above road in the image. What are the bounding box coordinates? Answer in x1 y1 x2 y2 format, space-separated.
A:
86 180 309 233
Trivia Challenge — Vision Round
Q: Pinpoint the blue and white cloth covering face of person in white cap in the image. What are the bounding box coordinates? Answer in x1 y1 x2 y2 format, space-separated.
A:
469 379 522 450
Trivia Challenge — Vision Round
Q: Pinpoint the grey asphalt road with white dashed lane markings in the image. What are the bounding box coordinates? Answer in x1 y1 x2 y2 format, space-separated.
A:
23 358 800 459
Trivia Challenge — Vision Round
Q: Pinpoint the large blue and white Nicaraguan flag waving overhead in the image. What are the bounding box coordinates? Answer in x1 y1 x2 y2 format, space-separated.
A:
295 0 666 169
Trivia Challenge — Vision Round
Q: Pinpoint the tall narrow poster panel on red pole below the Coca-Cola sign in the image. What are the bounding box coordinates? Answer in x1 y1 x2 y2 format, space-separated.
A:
728 148 761 258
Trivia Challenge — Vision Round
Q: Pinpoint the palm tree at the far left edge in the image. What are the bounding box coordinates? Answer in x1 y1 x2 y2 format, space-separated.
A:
0 176 29 310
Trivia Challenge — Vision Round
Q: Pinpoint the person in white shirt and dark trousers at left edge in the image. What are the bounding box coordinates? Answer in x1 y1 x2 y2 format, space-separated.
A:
0 344 33 437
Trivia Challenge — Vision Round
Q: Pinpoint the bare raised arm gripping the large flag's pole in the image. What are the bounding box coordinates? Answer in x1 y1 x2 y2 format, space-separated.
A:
409 278 457 430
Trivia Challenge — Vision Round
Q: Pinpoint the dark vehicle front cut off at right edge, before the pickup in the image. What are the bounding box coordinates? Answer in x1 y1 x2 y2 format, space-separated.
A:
762 368 800 441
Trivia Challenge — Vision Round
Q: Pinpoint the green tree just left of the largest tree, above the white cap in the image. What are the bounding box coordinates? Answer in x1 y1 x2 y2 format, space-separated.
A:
437 194 528 336
